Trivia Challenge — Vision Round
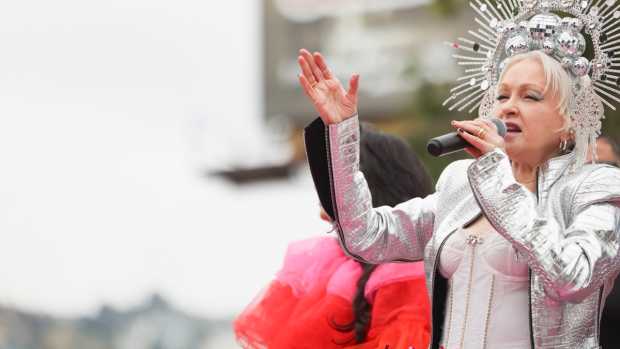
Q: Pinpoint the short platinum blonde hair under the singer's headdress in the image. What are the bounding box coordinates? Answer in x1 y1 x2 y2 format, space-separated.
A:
498 51 590 130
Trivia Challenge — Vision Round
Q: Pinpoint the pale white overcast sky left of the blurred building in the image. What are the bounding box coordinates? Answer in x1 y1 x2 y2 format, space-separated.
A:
0 0 328 316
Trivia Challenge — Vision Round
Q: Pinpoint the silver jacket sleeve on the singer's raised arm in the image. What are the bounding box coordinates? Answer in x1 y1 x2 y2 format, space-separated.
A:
328 116 441 263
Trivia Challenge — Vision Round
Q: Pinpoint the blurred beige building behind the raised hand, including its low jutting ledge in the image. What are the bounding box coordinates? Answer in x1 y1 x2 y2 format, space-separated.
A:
208 0 474 184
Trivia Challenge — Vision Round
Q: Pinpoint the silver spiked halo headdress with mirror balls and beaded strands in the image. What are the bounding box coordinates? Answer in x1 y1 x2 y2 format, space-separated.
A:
444 0 620 166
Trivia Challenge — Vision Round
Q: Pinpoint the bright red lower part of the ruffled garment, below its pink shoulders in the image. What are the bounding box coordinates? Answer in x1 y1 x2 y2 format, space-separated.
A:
235 279 430 349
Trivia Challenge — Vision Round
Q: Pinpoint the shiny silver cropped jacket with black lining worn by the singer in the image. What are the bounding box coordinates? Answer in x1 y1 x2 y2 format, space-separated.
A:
305 116 620 349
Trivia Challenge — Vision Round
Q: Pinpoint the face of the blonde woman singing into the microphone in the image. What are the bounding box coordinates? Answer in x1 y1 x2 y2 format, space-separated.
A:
494 59 565 165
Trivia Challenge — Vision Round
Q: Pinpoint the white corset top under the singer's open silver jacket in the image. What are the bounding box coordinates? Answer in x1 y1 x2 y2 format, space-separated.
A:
439 229 531 349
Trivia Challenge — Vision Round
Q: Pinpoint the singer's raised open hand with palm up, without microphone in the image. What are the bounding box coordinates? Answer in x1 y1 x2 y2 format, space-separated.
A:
297 49 359 124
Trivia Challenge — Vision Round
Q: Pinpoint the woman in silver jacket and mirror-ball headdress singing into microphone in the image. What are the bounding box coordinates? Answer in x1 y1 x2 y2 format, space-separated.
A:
299 1 620 349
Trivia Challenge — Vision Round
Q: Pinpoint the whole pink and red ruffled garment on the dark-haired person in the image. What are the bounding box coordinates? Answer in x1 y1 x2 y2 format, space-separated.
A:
234 240 430 349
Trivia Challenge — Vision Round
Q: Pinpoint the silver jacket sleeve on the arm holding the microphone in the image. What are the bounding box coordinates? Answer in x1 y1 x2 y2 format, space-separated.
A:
468 150 620 302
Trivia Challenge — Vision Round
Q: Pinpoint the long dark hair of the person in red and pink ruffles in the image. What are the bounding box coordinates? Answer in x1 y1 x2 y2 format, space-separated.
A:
330 124 433 344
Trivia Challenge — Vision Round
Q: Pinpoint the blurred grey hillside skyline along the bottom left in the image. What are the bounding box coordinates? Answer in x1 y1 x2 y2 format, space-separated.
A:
0 295 238 349
